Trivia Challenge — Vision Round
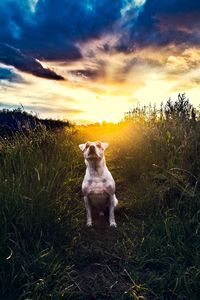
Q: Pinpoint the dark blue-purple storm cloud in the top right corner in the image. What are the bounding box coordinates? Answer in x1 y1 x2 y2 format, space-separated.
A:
126 0 200 47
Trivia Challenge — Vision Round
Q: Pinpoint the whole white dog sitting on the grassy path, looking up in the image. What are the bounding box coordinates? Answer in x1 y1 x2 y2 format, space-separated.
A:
79 142 118 227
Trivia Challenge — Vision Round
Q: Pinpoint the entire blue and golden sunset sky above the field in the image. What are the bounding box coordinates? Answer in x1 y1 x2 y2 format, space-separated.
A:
0 0 200 123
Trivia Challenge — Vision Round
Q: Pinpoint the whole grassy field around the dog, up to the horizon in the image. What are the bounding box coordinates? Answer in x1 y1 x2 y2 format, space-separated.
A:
0 95 200 300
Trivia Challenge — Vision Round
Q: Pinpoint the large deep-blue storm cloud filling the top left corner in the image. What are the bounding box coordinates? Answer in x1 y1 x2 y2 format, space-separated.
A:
0 0 123 60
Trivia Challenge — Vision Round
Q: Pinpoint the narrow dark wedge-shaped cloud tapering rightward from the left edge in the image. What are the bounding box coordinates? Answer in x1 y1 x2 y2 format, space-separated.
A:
0 44 64 80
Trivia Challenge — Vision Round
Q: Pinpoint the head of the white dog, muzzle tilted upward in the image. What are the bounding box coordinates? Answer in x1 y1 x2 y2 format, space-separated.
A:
79 142 108 160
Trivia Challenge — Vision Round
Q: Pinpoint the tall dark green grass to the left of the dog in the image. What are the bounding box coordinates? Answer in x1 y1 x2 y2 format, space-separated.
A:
0 127 83 299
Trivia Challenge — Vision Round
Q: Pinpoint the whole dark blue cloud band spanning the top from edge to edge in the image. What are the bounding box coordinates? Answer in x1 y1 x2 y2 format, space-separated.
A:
0 0 200 64
